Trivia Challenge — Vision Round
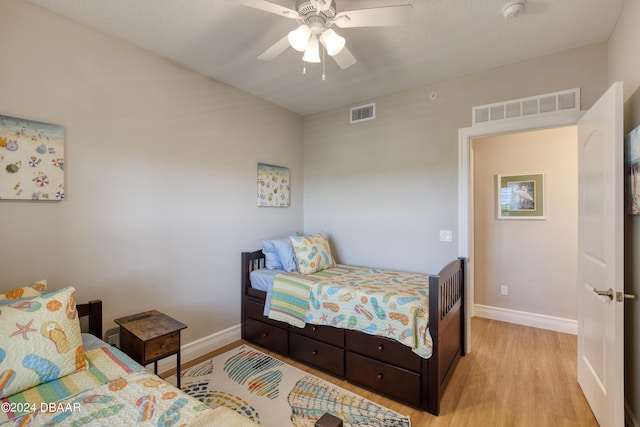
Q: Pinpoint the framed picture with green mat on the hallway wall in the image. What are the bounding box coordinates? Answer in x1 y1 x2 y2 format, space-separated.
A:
497 173 545 219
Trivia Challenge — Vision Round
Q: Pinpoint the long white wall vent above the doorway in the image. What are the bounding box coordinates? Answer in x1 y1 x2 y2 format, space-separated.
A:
471 88 580 126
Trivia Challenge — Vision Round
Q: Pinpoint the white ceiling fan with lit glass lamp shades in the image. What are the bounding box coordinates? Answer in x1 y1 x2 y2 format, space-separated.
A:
235 0 412 70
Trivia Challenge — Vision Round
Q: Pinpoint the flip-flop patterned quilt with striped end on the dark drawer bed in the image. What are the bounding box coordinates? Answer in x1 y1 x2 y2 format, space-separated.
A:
268 265 432 359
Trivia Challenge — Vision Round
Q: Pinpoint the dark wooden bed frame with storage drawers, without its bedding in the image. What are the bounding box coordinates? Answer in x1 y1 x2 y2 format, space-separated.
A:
242 251 465 415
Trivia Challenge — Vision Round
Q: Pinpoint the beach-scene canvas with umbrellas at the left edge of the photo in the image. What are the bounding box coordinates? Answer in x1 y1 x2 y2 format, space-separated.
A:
0 115 64 200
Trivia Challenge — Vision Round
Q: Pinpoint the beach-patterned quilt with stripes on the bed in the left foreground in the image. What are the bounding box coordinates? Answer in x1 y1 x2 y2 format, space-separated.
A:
0 346 211 427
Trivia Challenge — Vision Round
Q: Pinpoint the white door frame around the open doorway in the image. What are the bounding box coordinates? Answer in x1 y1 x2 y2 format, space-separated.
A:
458 111 584 353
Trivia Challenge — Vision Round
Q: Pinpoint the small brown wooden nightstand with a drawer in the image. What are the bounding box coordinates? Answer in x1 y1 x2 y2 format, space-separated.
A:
114 310 187 388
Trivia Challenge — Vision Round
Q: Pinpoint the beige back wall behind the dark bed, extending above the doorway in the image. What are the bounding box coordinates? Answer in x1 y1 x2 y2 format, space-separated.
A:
304 44 607 272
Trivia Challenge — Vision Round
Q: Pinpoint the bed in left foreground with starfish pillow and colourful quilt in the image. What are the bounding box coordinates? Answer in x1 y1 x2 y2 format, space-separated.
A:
0 281 254 427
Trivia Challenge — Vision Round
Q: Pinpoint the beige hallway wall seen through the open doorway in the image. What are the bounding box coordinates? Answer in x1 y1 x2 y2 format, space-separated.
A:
472 127 578 320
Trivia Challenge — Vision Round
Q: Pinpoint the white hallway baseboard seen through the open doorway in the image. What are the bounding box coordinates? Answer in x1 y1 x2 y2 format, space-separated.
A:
473 304 578 335
